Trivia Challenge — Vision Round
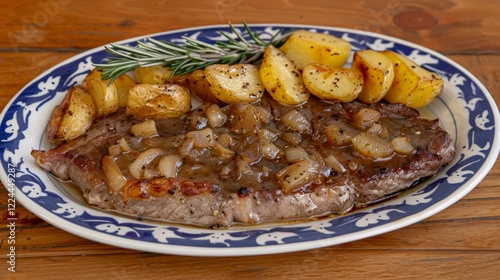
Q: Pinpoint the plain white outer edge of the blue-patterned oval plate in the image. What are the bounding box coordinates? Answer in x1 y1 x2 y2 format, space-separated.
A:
0 23 500 256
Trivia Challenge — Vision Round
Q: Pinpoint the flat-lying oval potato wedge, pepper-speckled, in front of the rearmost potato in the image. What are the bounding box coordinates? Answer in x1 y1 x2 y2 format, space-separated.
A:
302 63 363 102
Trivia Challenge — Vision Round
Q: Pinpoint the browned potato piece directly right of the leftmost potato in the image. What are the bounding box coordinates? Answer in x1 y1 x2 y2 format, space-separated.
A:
83 68 120 118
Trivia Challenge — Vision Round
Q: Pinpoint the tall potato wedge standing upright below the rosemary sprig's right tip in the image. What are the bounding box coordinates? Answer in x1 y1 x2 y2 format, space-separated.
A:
260 46 310 106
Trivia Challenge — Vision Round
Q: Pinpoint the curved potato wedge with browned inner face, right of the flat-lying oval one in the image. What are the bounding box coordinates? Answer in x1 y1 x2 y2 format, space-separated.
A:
352 50 394 103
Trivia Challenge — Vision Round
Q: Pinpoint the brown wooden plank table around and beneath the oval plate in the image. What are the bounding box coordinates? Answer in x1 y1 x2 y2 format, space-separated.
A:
0 0 500 279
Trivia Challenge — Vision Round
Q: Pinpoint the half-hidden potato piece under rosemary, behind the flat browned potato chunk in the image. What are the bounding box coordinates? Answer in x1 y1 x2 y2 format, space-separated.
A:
134 65 189 85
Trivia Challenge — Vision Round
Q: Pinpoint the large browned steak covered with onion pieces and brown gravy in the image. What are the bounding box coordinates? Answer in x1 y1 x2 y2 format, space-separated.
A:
32 98 454 228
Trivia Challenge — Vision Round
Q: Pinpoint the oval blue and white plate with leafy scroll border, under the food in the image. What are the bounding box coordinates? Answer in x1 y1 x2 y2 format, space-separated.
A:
0 24 500 256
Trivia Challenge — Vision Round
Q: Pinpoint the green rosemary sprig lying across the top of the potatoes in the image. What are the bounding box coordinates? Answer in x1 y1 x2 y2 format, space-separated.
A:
94 22 290 82
